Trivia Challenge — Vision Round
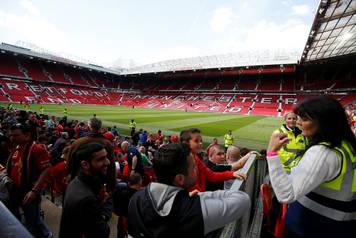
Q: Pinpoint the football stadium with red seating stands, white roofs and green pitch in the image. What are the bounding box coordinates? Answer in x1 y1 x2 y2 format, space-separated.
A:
0 0 356 237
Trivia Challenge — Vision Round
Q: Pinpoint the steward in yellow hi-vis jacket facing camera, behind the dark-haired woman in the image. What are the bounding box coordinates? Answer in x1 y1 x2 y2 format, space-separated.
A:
274 112 307 172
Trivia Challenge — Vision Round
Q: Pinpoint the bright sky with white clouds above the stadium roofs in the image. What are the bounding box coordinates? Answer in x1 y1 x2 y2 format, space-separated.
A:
0 0 319 65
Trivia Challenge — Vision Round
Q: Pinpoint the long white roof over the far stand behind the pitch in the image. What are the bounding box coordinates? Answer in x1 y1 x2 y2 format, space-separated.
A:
122 50 300 74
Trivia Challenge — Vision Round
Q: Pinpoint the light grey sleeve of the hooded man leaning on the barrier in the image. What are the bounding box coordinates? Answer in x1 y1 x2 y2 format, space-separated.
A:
199 190 251 235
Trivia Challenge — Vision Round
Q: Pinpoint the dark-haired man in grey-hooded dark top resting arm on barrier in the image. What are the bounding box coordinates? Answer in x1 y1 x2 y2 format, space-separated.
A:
128 144 250 238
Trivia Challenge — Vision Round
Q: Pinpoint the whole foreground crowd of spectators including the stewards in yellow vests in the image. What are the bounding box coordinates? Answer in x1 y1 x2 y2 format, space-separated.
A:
0 97 356 238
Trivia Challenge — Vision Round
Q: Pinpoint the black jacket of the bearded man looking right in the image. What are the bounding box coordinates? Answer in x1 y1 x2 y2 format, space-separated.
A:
59 173 110 238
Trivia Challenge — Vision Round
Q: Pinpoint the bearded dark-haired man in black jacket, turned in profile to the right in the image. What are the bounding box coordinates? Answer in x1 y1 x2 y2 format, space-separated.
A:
59 142 110 238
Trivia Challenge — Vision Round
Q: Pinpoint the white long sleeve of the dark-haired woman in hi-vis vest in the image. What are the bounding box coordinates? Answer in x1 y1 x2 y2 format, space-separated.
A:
267 145 341 203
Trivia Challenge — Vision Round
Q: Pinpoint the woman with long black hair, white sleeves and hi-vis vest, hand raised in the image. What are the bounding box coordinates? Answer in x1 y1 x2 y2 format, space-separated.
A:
267 96 356 237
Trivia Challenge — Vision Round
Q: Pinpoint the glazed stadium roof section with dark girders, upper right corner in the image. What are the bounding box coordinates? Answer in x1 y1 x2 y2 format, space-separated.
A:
301 0 356 62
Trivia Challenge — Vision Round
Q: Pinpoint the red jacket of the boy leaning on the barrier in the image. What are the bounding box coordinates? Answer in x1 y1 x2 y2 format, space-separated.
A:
188 155 234 192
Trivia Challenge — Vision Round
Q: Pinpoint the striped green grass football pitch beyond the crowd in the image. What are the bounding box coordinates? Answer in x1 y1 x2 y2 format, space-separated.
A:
2 104 282 149
